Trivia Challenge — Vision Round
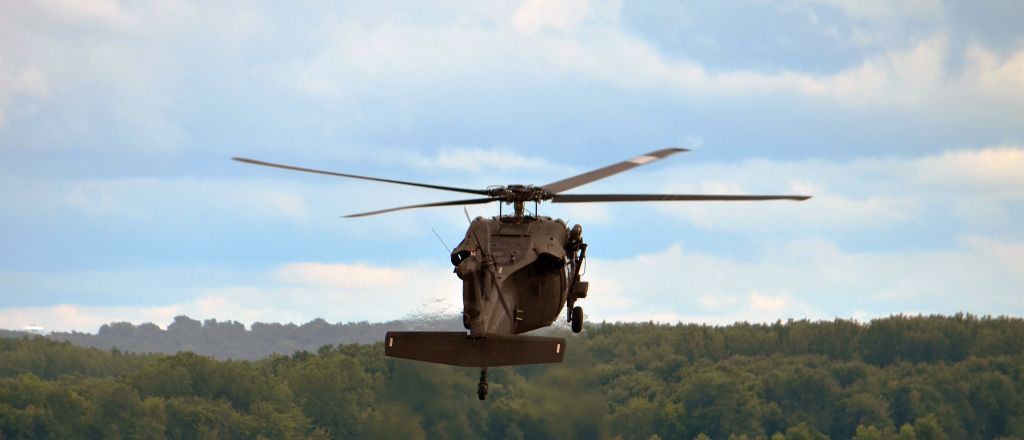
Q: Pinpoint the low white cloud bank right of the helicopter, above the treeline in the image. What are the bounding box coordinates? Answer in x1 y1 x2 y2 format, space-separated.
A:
580 237 1024 324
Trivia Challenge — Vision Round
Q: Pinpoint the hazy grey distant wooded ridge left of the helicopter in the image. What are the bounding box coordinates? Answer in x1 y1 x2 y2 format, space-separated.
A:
47 316 462 360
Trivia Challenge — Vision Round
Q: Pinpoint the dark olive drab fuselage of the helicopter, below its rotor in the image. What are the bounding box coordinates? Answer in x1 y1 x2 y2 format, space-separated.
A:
452 217 570 337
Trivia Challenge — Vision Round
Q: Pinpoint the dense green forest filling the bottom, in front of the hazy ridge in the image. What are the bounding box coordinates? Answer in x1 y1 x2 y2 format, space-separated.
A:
0 315 1024 440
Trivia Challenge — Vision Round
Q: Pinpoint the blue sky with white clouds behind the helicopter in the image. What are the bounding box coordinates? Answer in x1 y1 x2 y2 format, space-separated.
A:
0 0 1024 332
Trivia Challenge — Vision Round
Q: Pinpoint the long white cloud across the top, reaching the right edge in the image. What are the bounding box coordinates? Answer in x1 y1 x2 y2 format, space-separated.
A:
264 6 1024 108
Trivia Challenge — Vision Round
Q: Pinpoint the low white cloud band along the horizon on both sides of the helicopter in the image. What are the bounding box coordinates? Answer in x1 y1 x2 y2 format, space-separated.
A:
0 207 1024 331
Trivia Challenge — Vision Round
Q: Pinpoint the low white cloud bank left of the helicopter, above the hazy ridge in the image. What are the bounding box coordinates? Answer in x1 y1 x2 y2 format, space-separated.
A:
0 262 462 332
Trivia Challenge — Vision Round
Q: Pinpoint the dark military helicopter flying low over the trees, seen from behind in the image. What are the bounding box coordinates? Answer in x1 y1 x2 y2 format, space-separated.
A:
233 148 810 400
